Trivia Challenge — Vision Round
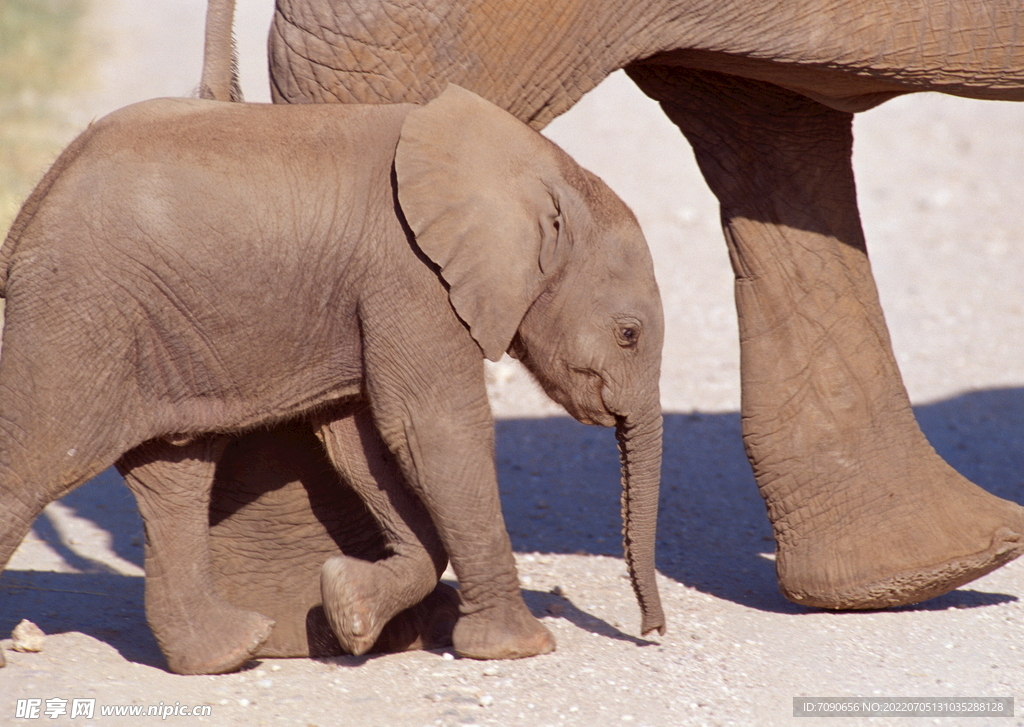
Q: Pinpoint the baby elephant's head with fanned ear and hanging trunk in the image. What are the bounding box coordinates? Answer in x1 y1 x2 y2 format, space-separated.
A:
395 85 665 633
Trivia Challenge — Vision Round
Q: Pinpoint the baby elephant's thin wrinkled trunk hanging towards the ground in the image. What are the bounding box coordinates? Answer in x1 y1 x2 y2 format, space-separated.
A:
615 394 665 634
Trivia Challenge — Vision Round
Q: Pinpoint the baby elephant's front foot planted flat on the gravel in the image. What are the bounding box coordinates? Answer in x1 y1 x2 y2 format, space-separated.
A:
452 595 555 658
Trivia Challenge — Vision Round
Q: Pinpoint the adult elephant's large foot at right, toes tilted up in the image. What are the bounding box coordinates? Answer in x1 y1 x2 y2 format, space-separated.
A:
773 453 1024 608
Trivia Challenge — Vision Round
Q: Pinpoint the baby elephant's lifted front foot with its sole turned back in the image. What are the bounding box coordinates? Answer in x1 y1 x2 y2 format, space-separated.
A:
321 555 396 656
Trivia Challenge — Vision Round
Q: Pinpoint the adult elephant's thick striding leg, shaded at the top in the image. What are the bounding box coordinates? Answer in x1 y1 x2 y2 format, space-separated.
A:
629 65 1024 608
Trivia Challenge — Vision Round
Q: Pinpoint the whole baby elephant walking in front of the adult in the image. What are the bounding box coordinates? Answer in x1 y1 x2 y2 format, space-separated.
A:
0 86 664 673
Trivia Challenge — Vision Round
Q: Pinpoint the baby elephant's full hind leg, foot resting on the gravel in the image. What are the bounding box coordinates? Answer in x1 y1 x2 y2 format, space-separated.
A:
118 437 273 674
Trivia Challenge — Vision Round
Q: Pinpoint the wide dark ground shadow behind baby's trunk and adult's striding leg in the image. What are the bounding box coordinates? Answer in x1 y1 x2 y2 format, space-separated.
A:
498 388 1024 613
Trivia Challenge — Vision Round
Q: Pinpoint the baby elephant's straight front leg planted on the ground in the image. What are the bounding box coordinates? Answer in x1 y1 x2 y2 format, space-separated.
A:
359 292 555 658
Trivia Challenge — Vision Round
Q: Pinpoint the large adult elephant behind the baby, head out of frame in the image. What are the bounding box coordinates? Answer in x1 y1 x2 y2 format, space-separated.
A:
270 0 1024 608
